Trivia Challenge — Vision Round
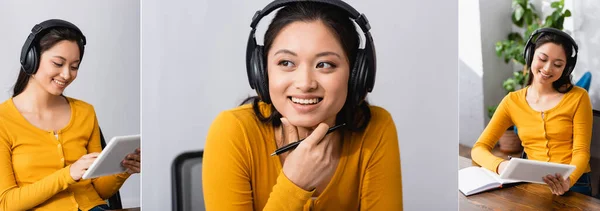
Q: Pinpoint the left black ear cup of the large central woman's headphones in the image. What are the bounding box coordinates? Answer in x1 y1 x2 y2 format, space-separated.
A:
252 46 271 103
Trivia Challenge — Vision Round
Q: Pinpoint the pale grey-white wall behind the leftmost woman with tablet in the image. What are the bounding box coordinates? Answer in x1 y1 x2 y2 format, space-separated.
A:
0 0 140 207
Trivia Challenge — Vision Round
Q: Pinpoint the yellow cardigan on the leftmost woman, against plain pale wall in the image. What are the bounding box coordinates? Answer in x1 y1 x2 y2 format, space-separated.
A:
0 98 129 211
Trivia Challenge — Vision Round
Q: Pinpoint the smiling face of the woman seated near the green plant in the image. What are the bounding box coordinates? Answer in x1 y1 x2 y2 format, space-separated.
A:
531 42 567 86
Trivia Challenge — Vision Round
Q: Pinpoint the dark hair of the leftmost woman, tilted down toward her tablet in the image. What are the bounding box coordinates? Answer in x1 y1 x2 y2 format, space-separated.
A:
12 27 83 97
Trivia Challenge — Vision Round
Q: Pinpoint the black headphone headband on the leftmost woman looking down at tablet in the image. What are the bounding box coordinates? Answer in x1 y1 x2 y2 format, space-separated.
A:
20 19 86 64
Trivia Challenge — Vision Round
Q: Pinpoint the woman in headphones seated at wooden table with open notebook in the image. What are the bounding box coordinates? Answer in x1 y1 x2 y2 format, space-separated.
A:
472 28 593 195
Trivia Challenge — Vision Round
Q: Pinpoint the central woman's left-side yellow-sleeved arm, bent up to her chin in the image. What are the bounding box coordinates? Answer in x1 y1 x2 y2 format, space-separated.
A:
202 112 312 211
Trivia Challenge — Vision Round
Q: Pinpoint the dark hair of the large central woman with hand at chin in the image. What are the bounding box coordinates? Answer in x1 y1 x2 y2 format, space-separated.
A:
241 2 371 131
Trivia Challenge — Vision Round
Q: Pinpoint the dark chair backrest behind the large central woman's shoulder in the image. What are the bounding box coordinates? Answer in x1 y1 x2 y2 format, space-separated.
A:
171 151 205 211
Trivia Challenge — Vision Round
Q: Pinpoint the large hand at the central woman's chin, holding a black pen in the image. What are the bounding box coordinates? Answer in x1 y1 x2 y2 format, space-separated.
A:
281 118 336 191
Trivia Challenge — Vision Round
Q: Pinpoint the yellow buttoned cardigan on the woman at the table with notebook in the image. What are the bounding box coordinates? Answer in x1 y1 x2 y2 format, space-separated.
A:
471 86 593 186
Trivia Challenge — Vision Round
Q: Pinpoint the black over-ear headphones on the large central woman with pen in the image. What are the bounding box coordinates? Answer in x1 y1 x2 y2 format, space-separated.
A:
246 0 376 105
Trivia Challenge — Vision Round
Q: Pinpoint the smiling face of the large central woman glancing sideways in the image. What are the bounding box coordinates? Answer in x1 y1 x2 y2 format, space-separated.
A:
267 21 350 128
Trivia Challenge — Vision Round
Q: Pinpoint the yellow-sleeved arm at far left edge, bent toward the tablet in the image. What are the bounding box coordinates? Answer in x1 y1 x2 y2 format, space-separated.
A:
0 123 75 210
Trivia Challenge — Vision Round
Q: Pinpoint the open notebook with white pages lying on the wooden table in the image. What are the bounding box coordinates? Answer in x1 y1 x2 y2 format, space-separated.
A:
458 166 520 196
